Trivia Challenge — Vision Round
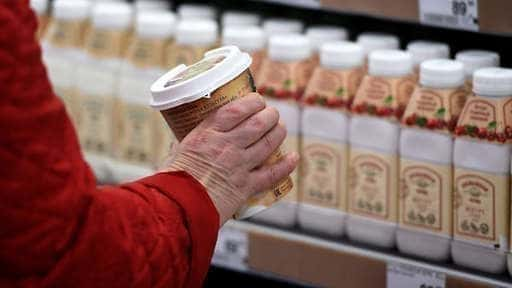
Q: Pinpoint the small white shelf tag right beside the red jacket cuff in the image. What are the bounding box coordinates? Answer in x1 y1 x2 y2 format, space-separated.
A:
212 227 249 271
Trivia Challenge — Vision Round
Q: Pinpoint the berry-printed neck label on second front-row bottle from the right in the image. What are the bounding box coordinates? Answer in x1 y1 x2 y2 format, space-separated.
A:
402 87 467 133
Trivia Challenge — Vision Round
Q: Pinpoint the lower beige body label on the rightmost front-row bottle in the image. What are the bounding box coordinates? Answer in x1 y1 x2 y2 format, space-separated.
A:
454 168 510 249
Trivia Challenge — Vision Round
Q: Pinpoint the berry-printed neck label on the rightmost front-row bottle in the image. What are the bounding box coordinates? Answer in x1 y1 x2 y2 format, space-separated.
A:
455 96 512 143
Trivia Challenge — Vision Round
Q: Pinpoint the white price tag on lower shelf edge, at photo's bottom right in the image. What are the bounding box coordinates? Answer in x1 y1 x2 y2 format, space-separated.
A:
386 262 446 288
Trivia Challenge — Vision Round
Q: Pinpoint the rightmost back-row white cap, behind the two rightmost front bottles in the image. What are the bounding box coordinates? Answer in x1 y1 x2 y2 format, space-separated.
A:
455 50 500 79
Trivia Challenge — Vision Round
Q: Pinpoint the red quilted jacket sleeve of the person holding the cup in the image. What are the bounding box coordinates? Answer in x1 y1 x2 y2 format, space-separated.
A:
0 0 219 288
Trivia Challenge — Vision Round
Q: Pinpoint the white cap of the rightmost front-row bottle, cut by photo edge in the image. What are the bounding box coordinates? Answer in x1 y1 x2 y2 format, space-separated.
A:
473 67 512 97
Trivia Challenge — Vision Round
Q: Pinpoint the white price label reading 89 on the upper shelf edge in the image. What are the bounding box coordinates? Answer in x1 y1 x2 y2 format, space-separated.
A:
419 0 479 31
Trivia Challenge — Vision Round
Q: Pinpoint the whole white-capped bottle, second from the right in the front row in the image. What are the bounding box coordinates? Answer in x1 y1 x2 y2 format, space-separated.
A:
397 59 467 261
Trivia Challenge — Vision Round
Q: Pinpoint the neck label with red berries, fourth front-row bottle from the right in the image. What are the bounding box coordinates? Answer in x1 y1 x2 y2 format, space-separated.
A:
304 67 363 110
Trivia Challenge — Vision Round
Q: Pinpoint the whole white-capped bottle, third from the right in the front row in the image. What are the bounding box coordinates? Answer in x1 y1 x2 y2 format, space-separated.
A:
346 50 415 248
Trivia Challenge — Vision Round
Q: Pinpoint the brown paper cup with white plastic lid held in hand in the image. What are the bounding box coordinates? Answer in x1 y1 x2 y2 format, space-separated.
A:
151 46 293 218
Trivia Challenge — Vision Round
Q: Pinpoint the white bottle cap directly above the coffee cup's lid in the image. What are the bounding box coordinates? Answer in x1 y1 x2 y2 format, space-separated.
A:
176 19 218 45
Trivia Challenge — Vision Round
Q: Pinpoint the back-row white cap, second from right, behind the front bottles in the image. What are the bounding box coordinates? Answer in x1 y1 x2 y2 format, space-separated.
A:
407 40 450 66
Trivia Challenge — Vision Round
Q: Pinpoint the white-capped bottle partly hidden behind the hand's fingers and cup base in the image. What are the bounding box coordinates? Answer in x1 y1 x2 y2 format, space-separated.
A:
253 34 312 227
